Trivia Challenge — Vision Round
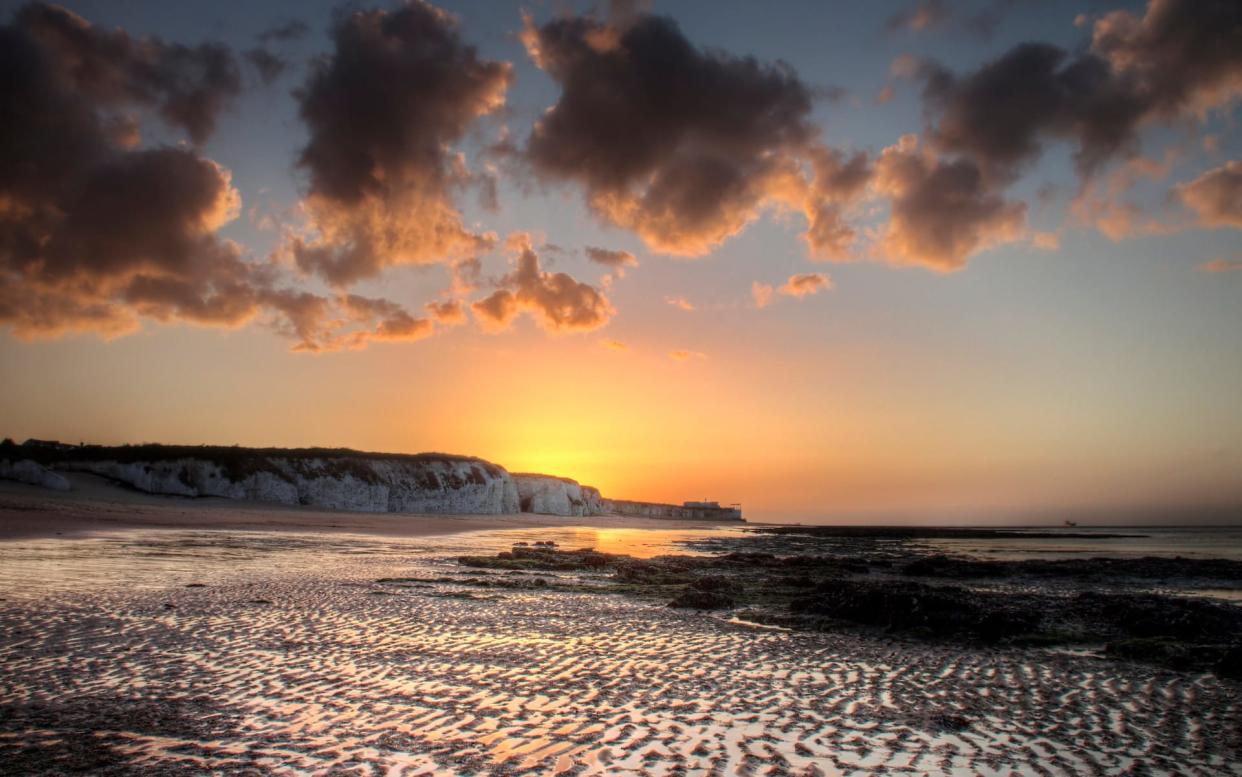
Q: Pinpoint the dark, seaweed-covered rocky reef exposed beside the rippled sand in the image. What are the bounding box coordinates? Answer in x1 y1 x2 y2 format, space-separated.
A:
458 545 1242 679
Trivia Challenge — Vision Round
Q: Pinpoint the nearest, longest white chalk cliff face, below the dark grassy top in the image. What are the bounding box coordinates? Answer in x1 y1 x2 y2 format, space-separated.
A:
60 457 518 514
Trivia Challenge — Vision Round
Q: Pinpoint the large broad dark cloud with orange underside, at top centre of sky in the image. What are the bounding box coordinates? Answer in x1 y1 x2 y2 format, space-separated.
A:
523 12 859 256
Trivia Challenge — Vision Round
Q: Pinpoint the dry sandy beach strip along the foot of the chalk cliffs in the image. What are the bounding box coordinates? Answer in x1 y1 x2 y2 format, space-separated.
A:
0 474 723 542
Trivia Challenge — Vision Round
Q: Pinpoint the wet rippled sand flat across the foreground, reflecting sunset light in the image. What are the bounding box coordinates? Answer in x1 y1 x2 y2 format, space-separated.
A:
0 531 1242 775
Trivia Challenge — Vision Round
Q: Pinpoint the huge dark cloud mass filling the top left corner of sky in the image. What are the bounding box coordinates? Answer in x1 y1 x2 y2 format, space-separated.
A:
0 5 258 336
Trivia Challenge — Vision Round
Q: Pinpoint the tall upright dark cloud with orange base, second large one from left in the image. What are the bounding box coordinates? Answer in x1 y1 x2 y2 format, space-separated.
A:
289 0 510 285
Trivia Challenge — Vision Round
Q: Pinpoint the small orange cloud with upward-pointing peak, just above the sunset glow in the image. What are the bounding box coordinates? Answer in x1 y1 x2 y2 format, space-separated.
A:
471 233 615 331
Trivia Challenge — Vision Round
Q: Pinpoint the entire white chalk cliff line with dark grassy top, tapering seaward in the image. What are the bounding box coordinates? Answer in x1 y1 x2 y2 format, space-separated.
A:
0 439 740 520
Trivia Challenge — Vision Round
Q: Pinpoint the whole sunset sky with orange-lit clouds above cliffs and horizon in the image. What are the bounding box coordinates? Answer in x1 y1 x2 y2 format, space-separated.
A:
0 0 1242 523
